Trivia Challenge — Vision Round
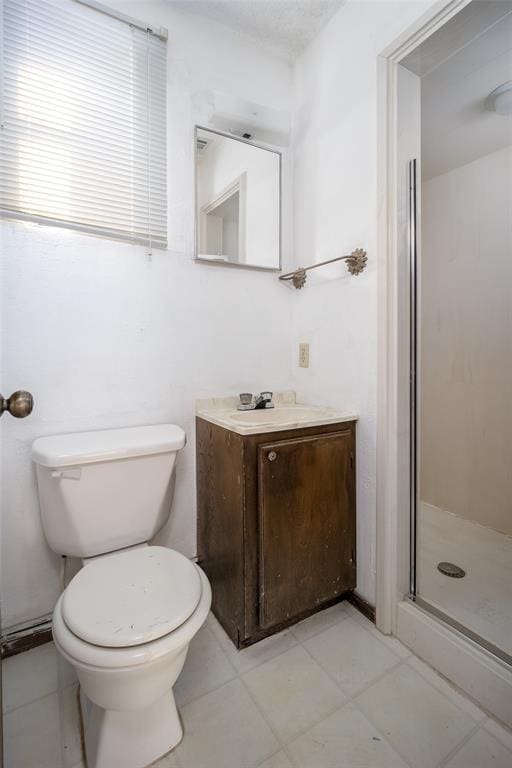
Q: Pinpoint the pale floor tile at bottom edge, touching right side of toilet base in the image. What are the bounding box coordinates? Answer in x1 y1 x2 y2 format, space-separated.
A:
176 679 279 768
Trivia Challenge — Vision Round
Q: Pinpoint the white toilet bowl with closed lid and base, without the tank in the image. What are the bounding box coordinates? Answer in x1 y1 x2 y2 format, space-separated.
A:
53 547 211 768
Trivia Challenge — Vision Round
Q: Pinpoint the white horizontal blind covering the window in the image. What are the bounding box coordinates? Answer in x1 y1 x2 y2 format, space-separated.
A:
0 0 167 247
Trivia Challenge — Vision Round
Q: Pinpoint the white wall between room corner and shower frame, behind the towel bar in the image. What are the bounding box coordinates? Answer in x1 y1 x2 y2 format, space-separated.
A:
293 0 431 602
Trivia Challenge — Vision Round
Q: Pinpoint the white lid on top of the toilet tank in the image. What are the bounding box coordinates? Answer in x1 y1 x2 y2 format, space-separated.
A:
32 424 186 467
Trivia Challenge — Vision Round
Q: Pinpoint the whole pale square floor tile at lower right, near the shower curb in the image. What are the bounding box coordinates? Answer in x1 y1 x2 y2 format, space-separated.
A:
357 664 475 768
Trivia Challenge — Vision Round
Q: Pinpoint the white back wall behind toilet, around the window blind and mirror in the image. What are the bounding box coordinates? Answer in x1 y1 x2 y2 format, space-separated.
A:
0 0 291 630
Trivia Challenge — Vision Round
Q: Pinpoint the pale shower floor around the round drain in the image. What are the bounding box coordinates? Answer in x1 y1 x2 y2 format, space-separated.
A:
418 502 512 656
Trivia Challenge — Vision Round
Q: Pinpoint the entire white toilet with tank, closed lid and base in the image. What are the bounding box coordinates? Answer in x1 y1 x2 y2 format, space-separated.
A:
32 424 211 768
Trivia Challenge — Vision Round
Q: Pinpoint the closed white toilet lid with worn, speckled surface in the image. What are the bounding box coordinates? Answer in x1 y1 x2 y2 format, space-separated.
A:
62 547 202 648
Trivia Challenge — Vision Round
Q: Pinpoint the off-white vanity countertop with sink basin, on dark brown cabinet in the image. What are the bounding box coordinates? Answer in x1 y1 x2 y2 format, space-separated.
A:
196 390 357 435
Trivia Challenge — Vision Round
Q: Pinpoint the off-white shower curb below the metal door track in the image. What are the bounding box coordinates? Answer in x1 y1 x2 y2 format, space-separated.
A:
396 601 512 728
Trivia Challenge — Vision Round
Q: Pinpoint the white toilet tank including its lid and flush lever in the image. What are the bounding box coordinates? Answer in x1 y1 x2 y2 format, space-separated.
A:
32 424 185 558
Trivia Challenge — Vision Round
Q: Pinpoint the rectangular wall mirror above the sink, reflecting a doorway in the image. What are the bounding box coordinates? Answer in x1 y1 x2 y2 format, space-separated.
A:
195 127 281 270
